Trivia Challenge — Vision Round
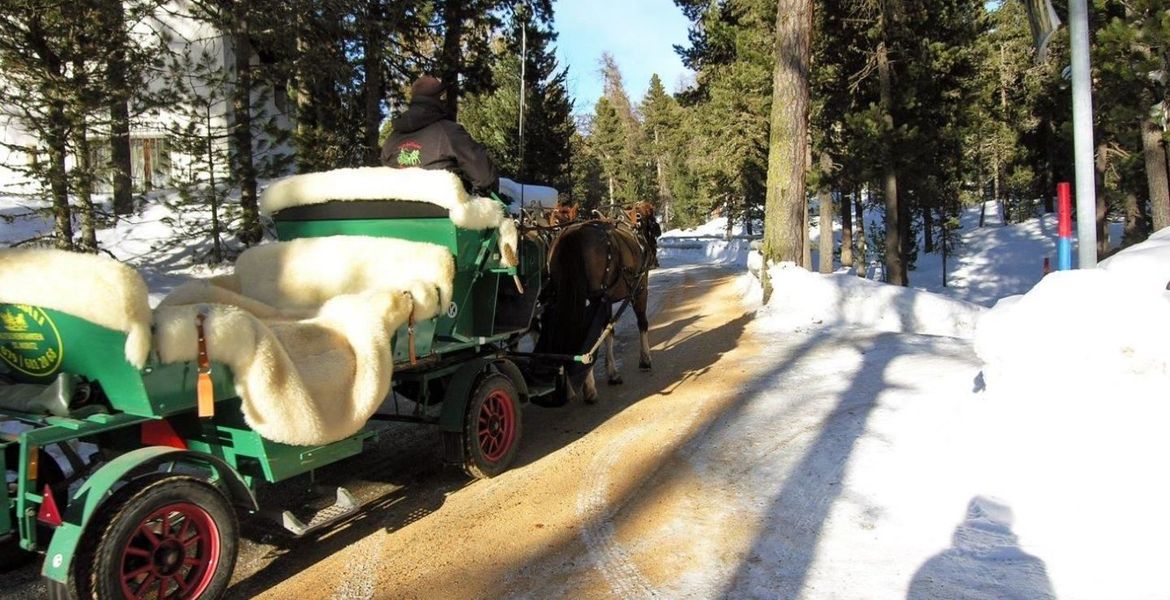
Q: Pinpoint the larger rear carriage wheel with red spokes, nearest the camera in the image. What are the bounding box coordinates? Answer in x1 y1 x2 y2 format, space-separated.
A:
69 476 239 600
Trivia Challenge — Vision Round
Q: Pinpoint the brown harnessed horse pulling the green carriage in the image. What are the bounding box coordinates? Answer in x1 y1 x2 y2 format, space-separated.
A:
536 209 655 402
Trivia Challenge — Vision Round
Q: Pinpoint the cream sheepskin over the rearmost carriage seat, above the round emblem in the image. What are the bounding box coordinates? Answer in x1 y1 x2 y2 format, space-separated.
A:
0 248 151 368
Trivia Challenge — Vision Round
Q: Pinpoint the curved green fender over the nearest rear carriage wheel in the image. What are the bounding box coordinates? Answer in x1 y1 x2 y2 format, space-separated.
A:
41 446 259 584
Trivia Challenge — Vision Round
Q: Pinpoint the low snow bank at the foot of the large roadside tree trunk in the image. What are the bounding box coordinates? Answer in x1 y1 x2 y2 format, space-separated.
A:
752 255 986 338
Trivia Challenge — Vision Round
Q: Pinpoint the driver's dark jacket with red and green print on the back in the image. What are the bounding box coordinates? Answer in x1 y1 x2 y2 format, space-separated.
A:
381 97 500 192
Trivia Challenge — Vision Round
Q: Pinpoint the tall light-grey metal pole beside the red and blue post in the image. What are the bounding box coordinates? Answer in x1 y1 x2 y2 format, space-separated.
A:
1068 0 1096 269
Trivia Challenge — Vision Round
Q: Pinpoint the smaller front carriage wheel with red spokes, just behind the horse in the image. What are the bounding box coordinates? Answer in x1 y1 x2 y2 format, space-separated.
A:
463 373 521 480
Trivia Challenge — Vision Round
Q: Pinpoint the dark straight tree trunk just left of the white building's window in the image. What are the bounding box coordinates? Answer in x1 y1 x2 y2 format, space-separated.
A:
105 2 135 214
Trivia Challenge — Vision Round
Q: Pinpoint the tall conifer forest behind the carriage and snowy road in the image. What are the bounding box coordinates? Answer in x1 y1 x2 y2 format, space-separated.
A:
0 0 1170 285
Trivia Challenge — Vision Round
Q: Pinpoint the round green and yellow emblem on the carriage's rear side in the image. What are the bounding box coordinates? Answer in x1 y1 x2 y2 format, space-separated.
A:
0 304 64 378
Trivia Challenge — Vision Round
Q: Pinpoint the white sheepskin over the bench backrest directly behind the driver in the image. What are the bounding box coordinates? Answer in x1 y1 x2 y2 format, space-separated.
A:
260 167 518 267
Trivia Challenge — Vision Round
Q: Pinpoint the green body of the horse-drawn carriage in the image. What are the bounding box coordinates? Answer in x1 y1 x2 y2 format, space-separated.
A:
0 190 555 584
